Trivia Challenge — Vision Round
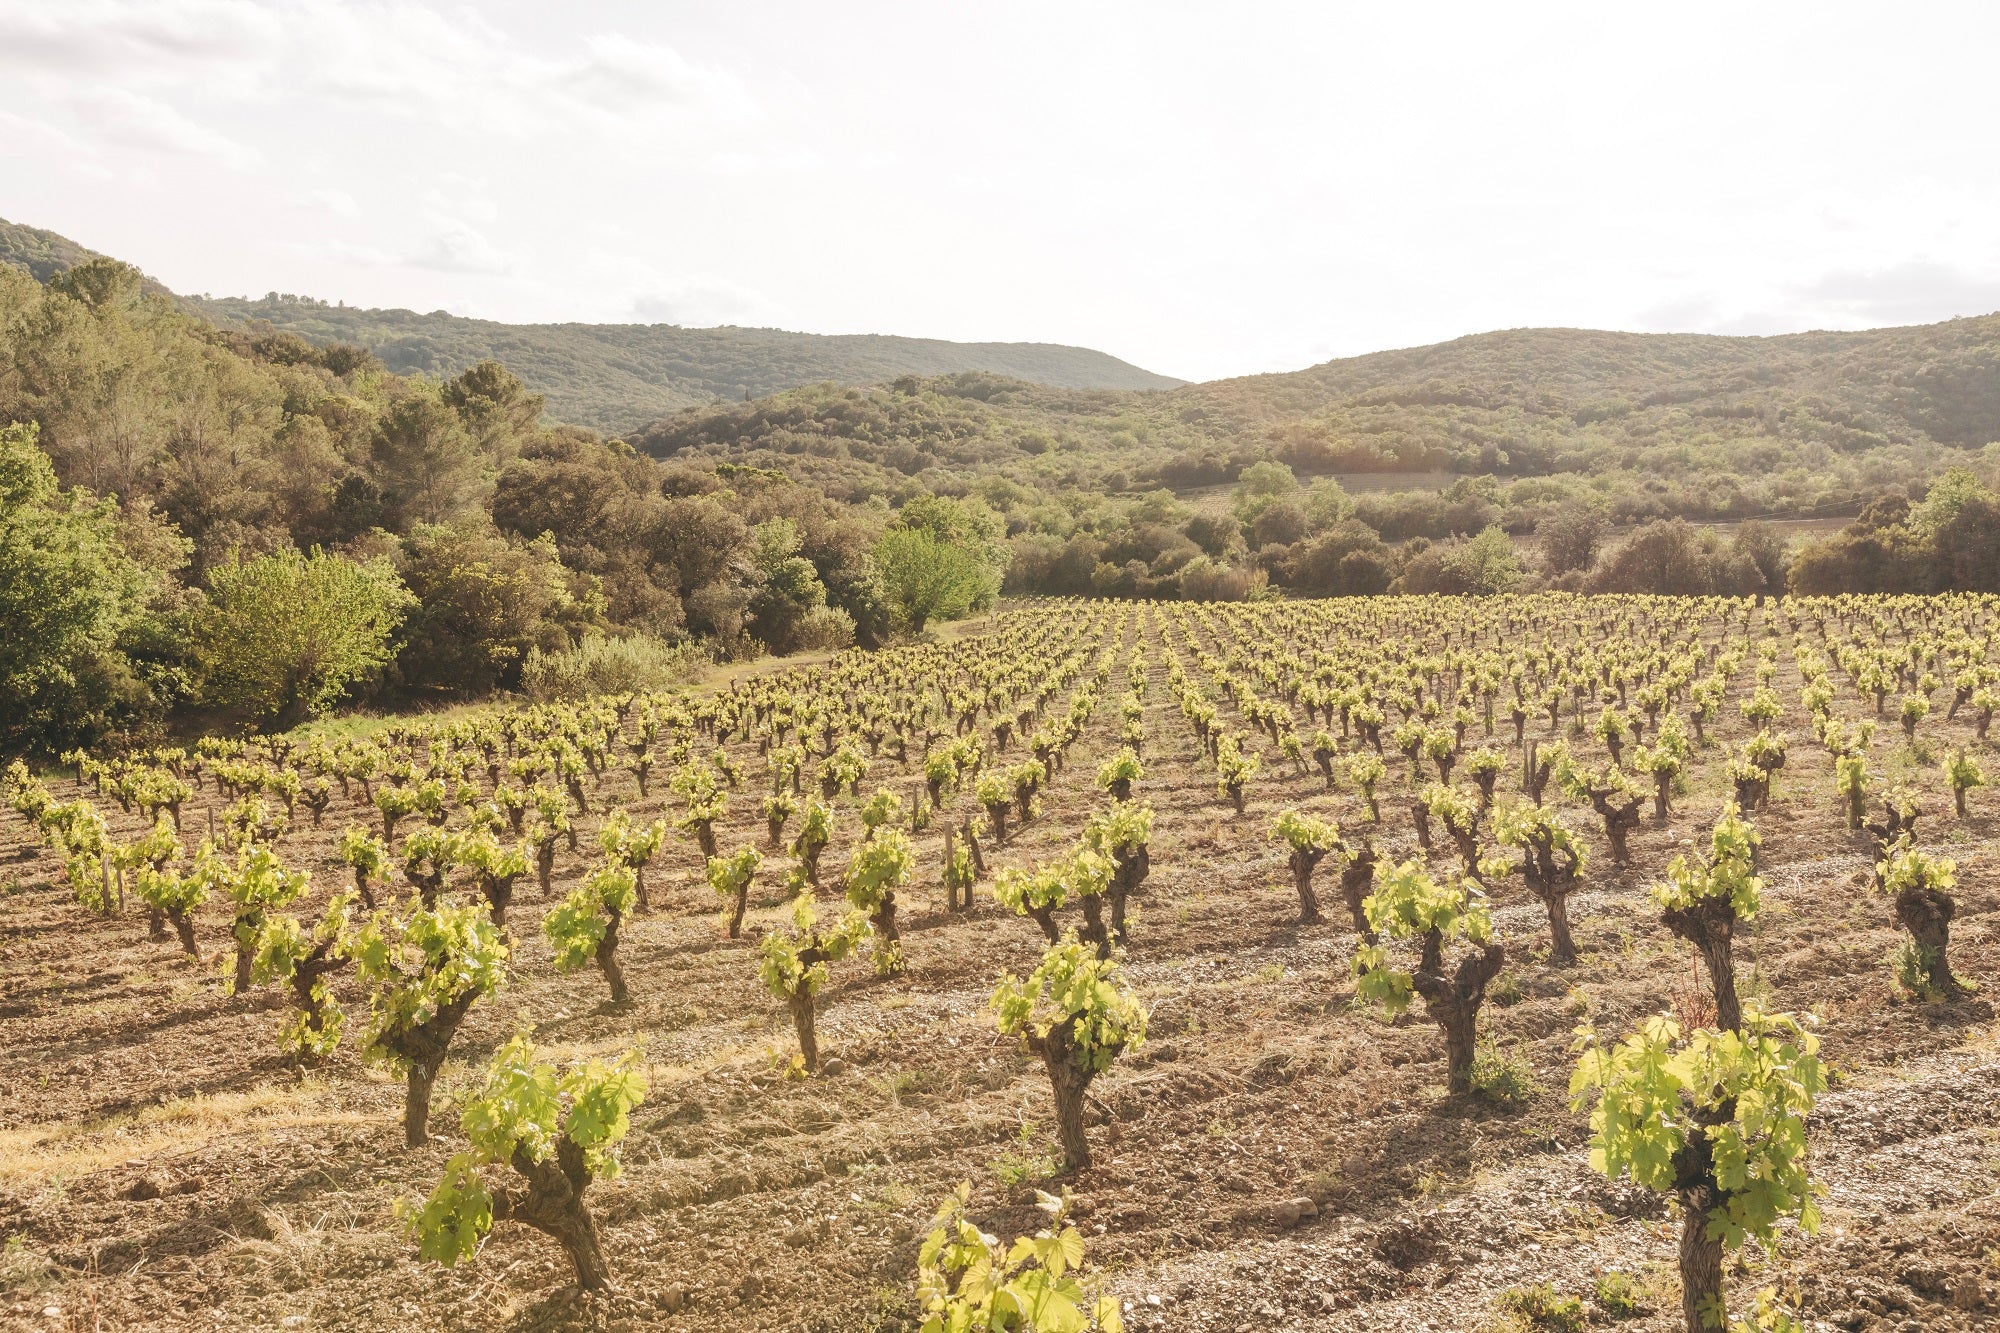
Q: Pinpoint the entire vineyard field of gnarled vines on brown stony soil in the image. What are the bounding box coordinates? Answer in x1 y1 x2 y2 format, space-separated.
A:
0 594 2000 1331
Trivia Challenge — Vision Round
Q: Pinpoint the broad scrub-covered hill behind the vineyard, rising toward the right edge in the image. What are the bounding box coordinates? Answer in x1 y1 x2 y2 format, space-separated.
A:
634 316 2000 534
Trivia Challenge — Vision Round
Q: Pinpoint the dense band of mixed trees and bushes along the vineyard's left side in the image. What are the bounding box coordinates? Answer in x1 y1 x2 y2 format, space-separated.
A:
0 258 1006 751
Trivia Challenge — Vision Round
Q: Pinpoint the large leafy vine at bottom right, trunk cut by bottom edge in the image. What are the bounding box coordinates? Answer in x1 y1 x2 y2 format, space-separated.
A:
1570 1013 1826 1333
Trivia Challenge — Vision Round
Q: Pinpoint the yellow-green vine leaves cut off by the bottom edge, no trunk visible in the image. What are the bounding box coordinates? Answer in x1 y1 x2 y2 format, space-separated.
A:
916 1185 1124 1333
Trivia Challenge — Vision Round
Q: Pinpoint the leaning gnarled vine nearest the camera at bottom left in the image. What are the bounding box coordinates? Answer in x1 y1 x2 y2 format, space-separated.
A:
398 1037 646 1291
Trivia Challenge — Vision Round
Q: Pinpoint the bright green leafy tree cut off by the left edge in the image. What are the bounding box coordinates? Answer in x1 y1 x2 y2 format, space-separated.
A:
0 422 168 753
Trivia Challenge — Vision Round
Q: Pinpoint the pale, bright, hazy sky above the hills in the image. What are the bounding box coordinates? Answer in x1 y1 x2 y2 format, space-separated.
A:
0 0 2000 380
